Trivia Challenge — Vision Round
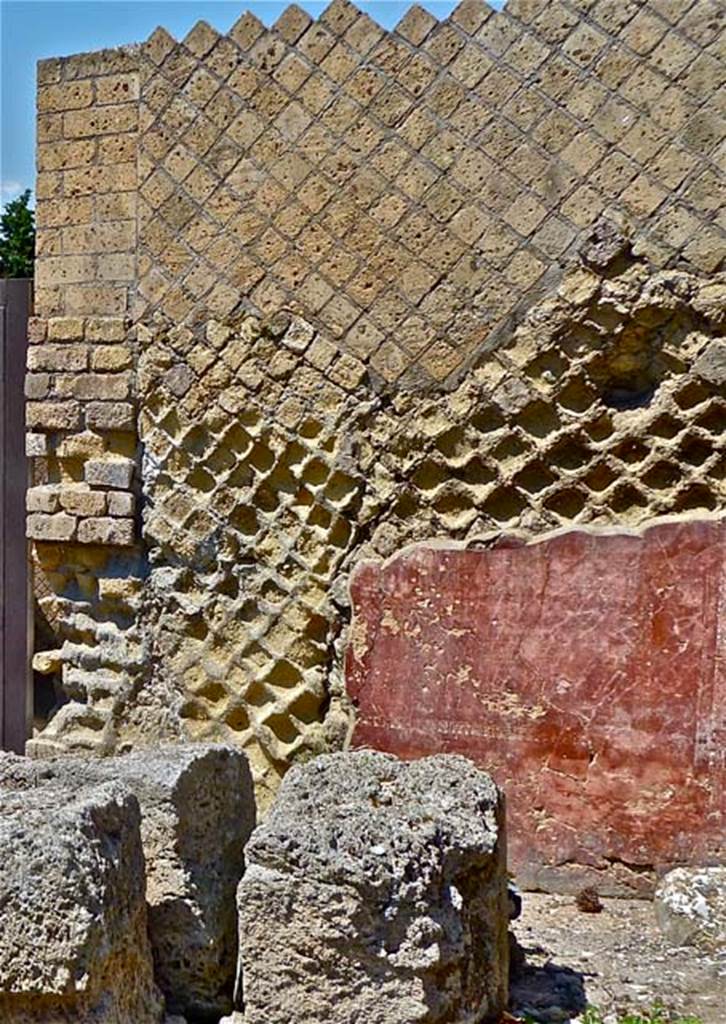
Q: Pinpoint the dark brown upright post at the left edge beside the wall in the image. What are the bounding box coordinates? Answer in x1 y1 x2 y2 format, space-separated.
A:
0 279 31 754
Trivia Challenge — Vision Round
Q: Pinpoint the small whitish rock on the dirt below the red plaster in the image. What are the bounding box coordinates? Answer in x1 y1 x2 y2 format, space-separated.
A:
654 867 726 950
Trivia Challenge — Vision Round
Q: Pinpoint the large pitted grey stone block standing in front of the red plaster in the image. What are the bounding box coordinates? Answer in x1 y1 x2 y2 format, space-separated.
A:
238 752 508 1024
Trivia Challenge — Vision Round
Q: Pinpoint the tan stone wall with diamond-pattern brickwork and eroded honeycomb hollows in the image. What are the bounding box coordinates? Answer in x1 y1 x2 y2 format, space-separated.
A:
28 0 726 793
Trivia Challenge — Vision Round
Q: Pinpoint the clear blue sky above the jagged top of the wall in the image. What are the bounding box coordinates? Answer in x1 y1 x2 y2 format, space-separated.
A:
0 0 500 203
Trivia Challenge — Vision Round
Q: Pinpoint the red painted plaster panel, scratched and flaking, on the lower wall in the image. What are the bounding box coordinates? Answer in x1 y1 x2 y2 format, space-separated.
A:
346 520 726 892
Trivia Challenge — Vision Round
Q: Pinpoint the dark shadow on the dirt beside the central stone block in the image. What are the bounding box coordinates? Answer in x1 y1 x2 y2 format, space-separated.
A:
509 946 588 1024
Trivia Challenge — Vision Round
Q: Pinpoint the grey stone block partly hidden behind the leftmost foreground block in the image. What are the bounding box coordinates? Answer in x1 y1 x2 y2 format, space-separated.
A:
0 744 255 1022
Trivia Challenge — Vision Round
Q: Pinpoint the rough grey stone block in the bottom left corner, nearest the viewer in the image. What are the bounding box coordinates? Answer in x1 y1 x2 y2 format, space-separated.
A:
0 778 163 1024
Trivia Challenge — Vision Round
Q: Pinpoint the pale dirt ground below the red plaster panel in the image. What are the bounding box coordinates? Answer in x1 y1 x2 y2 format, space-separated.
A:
510 893 726 1024
